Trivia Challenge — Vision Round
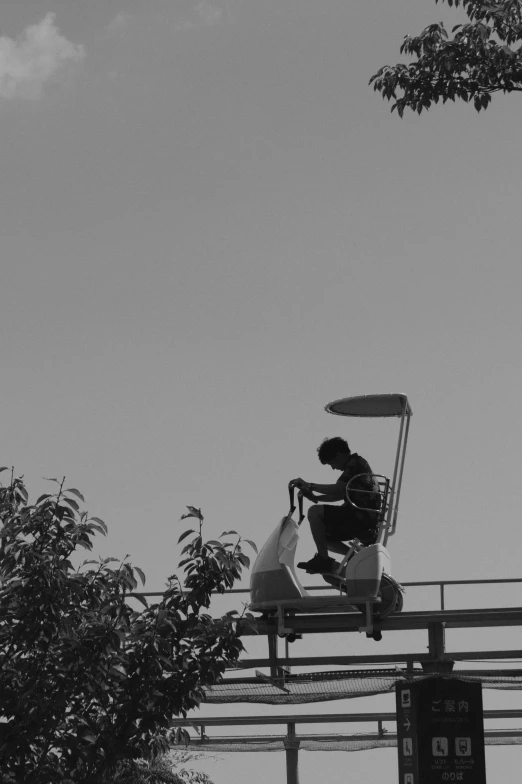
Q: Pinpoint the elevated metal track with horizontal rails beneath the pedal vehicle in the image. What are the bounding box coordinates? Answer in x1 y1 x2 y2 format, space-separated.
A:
132 578 522 784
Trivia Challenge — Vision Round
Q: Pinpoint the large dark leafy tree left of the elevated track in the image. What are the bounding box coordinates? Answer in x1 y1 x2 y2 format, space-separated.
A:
0 469 254 784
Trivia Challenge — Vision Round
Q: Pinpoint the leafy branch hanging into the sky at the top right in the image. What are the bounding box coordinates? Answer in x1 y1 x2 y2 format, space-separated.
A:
370 0 522 117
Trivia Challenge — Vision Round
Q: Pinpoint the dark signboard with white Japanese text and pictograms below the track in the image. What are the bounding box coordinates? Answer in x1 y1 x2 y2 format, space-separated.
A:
396 677 486 784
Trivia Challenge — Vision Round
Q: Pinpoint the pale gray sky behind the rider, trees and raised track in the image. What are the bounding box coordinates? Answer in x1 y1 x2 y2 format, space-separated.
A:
0 0 522 784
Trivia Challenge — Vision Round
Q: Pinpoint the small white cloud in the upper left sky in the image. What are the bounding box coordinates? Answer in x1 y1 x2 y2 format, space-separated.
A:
0 14 85 99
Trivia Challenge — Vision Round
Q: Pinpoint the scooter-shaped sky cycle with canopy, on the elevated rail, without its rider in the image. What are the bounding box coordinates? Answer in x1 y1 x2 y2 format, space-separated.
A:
250 394 412 641
